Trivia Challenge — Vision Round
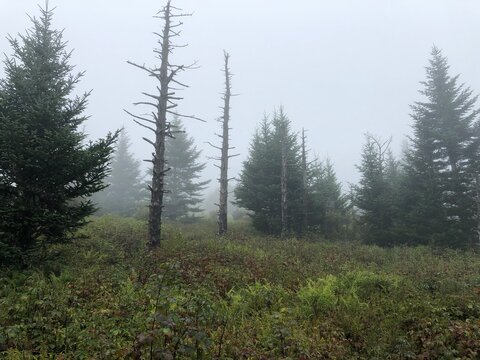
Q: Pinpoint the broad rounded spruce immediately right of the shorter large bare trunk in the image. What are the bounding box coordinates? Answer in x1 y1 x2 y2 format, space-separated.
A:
235 109 303 234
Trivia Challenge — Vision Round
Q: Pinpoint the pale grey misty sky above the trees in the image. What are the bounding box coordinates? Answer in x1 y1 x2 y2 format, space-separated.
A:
0 0 480 191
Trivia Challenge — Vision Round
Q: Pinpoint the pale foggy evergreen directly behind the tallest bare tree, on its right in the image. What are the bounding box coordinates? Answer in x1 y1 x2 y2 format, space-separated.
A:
164 117 210 222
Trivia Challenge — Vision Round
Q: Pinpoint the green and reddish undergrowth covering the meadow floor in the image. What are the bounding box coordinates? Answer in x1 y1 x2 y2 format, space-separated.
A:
0 217 480 359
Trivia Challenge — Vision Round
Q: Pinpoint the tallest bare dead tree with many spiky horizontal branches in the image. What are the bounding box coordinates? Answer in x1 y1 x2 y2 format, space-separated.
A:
125 0 201 248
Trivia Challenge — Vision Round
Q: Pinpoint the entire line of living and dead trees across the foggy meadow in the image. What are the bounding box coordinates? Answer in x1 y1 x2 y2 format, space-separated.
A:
0 1 480 268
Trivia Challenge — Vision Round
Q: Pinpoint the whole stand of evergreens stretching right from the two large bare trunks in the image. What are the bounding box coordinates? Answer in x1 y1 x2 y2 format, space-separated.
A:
235 46 480 249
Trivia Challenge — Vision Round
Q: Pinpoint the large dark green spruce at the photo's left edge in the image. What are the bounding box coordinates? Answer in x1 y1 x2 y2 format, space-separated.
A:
0 8 116 260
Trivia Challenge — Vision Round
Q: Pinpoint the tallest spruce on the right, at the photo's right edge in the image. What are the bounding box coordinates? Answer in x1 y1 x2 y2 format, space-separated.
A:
404 47 479 247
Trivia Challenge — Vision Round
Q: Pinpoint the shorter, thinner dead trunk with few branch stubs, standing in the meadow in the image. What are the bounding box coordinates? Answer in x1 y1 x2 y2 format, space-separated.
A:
208 51 238 235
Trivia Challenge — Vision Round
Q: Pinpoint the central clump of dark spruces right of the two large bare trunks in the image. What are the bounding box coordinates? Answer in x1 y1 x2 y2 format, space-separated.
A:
235 109 347 237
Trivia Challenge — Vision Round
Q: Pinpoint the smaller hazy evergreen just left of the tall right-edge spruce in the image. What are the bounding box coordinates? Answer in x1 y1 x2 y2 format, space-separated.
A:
353 135 398 246
